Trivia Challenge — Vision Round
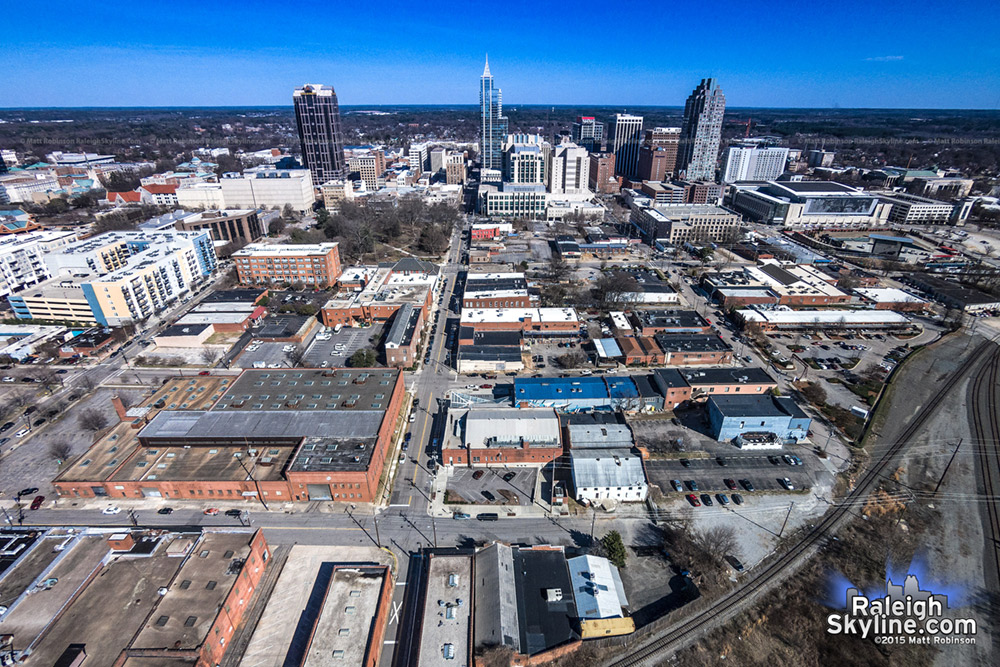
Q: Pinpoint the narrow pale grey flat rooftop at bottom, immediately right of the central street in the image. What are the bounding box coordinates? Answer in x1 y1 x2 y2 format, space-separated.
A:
417 555 472 666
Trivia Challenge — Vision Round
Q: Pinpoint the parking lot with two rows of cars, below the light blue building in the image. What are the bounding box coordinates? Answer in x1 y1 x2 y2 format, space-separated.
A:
646 450 824 499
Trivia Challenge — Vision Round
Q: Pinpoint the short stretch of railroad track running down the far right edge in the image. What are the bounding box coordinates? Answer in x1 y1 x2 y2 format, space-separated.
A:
971 344 1000 628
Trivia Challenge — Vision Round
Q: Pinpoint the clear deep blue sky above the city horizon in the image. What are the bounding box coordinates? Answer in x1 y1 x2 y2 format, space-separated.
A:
0 0 1000 109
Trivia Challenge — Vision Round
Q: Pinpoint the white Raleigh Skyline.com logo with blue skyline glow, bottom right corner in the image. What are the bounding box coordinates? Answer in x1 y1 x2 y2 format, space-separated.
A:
826 574 977 645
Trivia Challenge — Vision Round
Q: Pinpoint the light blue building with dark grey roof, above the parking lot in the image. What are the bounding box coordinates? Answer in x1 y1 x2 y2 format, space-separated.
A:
708 394 811 442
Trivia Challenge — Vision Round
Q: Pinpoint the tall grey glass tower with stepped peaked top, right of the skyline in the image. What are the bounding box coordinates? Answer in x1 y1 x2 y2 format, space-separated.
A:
677 79 726 181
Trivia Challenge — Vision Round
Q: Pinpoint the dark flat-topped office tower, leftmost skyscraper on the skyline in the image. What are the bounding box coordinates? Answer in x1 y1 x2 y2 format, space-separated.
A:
292 84 347 186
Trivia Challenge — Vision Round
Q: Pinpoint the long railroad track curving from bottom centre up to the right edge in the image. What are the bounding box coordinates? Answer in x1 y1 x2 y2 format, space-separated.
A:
607 342 1000 667
